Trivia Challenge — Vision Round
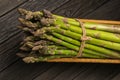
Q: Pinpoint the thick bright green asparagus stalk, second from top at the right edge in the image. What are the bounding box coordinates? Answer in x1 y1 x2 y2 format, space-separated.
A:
54 20 120 43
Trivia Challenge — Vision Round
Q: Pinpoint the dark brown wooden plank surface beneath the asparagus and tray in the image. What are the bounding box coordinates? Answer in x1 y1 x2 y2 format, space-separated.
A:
0 0 120 80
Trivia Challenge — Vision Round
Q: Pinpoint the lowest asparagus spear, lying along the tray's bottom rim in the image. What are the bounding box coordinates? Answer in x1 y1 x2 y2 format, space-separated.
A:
23 50 101 63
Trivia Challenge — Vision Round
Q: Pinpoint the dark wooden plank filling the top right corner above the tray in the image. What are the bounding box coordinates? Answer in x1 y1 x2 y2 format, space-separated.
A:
85 0 120 20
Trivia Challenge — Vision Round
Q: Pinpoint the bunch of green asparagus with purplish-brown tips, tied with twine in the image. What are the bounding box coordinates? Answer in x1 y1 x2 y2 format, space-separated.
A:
18 8 120 63
